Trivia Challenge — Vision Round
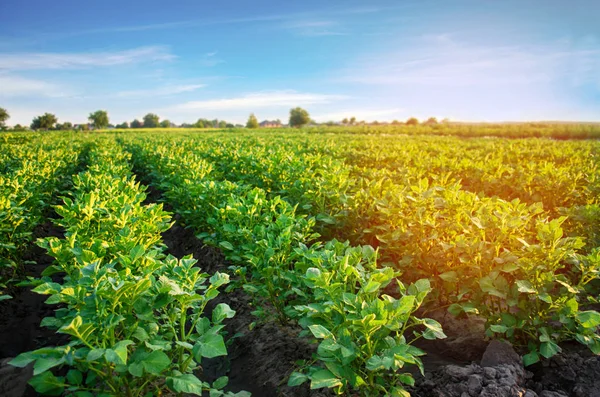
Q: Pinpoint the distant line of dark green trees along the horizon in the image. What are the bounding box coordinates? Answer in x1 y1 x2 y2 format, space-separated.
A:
0 107 440 131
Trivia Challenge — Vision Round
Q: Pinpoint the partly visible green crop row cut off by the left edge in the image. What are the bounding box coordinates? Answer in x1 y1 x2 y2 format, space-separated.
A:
0 136 82 299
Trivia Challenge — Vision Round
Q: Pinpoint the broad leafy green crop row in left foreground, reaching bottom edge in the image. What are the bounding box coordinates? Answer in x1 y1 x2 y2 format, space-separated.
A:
10 140 249 397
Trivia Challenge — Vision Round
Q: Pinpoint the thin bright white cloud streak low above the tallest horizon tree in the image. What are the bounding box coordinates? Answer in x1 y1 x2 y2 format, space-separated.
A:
165 90 347 112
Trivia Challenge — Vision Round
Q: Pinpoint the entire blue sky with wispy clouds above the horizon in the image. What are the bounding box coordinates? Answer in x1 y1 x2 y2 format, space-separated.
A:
0 0 600 124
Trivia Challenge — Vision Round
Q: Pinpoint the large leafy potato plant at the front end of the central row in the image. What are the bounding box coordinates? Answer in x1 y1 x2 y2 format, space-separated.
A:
289 240 446 396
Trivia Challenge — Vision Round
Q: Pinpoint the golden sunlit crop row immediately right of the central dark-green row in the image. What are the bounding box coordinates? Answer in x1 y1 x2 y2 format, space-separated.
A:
125 132 600 363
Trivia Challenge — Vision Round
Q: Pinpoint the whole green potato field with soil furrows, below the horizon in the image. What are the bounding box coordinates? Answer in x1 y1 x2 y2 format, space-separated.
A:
0 126 600 397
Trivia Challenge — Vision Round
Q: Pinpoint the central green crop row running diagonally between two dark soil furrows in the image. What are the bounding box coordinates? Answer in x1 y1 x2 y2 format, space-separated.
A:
130 138 445 396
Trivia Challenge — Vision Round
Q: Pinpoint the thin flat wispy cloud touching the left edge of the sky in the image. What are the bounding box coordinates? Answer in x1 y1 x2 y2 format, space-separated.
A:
0 46 175 70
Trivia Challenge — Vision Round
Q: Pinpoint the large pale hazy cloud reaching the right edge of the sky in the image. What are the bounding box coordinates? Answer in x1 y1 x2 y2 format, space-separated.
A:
338 34 600 87
